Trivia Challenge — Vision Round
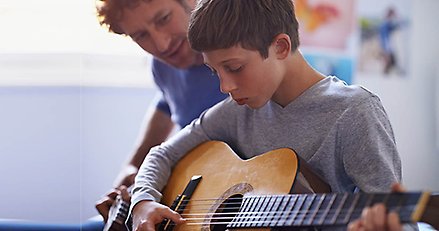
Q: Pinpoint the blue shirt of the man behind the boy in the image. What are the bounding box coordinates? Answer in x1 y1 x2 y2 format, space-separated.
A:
152 59 227 128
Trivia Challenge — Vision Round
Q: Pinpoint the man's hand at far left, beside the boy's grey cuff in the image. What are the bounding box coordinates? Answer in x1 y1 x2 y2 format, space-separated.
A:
95 185 131 223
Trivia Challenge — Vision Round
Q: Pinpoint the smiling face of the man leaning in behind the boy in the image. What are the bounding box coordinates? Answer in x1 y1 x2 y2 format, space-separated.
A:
119 0 202 68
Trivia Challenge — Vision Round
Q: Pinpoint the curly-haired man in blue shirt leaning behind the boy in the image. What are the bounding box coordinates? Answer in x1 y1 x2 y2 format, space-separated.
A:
96 0 227 223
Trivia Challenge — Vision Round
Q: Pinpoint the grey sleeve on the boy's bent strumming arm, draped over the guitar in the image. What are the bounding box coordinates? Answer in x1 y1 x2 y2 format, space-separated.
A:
130 98 234 211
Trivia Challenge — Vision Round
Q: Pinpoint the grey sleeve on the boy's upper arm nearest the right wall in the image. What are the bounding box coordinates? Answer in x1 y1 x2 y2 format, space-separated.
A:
338 97 401 192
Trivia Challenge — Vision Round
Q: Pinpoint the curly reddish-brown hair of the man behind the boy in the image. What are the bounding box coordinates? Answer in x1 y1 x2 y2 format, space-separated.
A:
96 0 188 34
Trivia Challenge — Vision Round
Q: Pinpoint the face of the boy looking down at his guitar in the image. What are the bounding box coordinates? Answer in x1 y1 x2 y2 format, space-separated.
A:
203 46 282 109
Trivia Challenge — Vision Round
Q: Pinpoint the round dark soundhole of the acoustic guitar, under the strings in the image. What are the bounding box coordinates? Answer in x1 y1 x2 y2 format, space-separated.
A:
210 194 243 231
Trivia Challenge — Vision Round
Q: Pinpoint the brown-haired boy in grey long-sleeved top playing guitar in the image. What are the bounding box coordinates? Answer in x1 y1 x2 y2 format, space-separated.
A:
131 0 401 230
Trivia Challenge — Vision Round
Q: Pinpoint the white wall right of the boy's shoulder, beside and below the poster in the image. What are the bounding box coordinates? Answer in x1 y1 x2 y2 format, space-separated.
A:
356 0 439 191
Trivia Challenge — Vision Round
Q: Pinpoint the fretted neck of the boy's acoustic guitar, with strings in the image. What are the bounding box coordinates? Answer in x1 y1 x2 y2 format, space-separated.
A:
227 193 437 228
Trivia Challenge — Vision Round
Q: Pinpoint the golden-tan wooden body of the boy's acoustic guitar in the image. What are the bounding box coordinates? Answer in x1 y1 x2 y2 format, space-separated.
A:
162 141 298 230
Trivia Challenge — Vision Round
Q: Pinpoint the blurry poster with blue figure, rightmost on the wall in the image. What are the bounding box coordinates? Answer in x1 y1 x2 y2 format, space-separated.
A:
357 0 410 77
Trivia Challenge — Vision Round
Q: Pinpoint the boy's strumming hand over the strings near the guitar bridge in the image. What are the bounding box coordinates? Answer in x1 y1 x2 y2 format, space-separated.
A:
132 201 185 231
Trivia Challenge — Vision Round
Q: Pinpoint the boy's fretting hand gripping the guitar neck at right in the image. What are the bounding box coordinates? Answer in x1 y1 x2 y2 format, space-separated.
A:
348 184 405 231
